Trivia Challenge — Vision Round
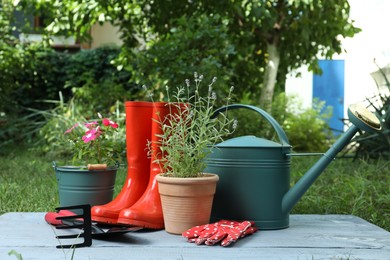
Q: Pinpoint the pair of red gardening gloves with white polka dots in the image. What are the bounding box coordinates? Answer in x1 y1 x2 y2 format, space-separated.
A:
182 220 257 246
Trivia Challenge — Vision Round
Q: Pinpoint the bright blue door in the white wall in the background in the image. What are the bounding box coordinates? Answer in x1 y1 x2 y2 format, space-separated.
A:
313 60 344 136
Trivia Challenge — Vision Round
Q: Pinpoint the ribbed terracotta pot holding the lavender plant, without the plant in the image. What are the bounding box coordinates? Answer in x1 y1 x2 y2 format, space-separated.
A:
156 173 219 234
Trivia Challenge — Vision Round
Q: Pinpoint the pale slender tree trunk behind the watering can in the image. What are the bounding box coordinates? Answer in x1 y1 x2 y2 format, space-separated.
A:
259 43 280 113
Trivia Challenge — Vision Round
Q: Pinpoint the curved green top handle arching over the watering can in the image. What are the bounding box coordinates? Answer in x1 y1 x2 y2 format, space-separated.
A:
211 104 291 152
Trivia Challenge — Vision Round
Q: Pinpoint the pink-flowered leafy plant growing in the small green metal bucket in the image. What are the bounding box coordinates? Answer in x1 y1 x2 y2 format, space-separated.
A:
64 113 120 164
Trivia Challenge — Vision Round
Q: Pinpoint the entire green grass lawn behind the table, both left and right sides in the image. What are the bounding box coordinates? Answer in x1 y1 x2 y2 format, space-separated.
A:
0 150 390 231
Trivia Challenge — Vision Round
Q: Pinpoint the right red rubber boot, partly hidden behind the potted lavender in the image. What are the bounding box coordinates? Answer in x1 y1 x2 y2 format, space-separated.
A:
118 102 170 229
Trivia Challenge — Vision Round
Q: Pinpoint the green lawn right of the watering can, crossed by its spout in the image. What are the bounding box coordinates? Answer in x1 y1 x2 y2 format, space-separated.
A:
291 157 390 230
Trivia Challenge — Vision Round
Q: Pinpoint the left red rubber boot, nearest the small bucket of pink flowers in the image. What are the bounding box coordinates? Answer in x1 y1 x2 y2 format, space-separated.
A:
91 101 154 224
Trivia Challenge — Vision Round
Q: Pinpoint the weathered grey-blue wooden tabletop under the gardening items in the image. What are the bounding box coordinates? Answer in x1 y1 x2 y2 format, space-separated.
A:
0 212 390 260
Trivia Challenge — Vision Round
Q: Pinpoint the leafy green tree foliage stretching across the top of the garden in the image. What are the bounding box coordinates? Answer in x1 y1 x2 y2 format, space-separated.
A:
21 0 360 110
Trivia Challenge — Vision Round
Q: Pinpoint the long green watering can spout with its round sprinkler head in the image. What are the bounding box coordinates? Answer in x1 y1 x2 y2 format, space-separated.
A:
282 105 381 213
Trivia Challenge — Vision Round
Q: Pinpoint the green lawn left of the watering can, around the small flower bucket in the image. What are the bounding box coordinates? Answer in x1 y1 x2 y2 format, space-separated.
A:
0 150 126 214
